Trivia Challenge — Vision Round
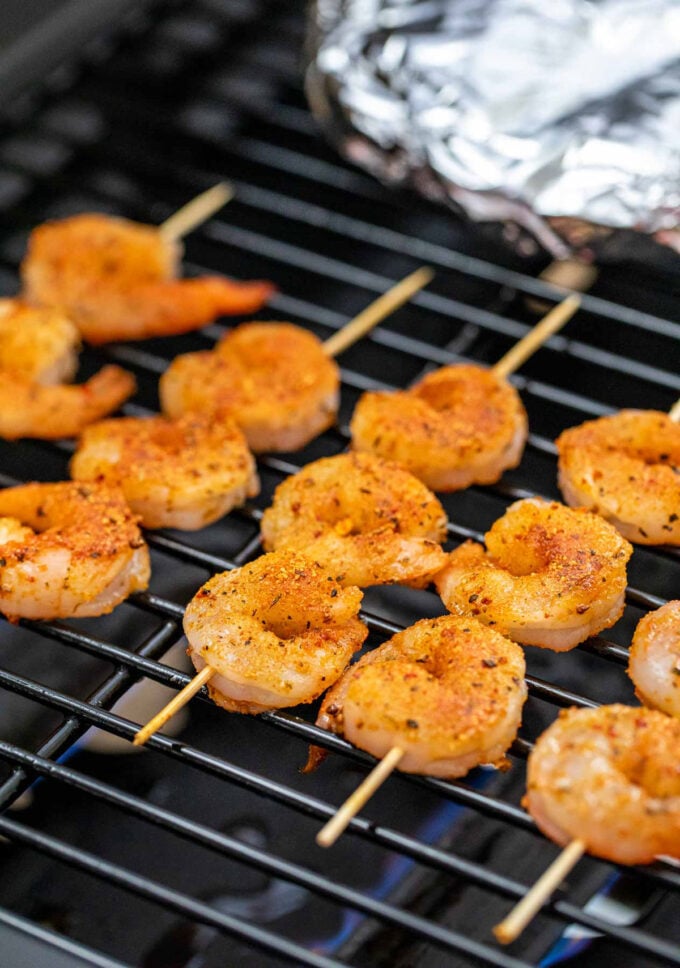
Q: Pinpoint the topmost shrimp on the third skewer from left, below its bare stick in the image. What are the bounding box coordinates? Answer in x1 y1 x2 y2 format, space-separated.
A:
350 365 528 491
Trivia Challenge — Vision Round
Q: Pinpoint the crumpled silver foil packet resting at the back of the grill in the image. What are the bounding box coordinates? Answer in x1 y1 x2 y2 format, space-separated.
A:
306 0 680 272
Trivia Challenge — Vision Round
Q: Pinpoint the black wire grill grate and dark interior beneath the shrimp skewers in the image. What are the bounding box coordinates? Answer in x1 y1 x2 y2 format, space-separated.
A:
0 0 680 968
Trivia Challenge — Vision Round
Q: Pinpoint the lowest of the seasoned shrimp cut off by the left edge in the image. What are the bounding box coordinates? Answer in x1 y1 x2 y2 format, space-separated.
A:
0 481 149 621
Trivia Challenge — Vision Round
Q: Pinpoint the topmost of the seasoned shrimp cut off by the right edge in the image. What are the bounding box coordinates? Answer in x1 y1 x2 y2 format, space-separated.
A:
555 410 680 545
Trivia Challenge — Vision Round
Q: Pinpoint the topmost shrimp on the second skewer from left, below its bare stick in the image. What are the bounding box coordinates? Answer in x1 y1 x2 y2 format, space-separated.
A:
160 323 340 453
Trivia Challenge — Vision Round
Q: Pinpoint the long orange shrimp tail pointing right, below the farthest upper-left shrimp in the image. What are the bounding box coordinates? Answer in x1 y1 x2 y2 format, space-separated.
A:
81 276 275 345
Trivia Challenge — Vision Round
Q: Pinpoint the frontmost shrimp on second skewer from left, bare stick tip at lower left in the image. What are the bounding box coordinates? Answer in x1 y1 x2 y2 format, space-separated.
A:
184 552 368 713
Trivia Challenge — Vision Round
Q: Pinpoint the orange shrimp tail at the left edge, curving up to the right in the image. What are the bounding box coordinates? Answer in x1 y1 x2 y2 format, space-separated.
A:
0 366 135 440
